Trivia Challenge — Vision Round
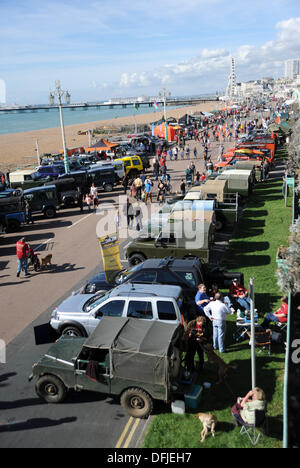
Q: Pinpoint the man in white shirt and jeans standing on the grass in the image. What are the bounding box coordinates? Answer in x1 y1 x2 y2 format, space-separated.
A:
204 292 231 353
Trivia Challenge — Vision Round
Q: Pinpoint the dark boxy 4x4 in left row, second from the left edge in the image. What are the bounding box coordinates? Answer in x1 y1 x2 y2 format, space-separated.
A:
23 185 60 219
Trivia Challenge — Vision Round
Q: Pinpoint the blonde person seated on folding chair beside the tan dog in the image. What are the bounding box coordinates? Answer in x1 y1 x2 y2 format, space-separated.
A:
231 387 266 426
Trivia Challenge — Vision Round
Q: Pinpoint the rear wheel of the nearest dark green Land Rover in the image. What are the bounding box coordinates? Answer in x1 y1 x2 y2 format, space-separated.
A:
121 388 153 419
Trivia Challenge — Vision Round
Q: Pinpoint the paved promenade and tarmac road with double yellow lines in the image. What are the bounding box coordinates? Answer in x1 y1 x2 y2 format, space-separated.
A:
0 132 232 448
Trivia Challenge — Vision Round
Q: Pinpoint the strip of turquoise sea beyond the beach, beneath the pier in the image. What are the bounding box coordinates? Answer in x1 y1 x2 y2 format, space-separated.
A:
0 105 182 135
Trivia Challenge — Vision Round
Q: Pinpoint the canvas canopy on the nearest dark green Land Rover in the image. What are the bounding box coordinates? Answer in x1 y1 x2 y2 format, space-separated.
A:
85 317 180 384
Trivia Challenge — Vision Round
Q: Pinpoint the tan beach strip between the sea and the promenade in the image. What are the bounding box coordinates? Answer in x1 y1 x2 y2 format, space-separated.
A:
0 102 224 171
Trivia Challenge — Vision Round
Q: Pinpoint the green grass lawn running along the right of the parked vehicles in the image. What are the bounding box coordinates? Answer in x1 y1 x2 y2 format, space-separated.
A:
143 150 292 448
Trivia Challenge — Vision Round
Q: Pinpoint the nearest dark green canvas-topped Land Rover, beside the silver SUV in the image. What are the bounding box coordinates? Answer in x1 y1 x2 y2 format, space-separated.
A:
29 317 186 418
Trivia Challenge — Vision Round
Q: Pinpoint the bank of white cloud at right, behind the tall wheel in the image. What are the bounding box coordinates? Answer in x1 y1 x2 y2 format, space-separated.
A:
120 18 300 92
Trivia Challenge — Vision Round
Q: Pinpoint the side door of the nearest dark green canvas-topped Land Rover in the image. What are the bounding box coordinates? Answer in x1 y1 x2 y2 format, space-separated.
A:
75 348 110 393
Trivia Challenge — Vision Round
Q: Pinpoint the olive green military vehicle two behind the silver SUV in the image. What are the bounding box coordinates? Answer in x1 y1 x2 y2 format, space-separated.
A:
124 217 215 266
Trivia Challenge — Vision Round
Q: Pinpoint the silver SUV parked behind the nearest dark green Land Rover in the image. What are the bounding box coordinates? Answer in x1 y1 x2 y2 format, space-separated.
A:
50 283 183 337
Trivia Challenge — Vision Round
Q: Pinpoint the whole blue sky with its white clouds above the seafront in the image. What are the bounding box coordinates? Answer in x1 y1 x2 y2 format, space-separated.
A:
0 0 300 105
